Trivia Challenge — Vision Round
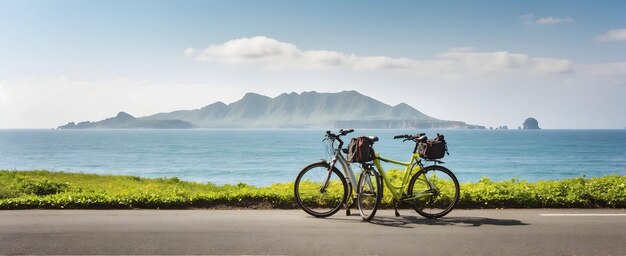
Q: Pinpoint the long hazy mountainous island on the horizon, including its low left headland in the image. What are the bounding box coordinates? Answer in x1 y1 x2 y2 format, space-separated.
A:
58 91 485 129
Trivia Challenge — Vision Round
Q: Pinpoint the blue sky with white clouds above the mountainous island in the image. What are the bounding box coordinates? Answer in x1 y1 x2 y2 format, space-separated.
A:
0 0 626 128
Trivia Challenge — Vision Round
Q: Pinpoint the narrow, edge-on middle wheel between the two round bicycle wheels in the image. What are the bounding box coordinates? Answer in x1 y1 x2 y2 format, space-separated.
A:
357 169 383 221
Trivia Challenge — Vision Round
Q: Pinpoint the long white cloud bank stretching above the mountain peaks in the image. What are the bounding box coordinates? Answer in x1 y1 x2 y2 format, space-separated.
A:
184 36 572 75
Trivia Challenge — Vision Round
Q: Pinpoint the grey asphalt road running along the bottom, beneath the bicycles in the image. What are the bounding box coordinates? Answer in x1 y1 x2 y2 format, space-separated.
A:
0 209 626 255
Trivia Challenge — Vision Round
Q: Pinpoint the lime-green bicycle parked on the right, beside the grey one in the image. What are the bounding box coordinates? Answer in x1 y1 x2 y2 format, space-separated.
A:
357 133 460 221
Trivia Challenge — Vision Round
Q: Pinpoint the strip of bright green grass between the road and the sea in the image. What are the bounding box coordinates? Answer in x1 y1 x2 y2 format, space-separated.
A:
0 171 626 209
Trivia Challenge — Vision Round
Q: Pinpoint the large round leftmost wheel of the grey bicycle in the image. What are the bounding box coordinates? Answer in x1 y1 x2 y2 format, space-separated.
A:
294 161 348 218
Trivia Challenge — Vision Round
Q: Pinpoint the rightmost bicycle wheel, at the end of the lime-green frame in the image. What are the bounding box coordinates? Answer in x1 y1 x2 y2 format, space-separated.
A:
408 165 460 219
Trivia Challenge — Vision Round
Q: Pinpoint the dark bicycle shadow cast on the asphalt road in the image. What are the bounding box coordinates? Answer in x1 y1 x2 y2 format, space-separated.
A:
371 216 528 228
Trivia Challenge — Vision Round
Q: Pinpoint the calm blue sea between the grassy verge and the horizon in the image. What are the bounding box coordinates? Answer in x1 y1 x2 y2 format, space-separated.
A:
0 130 626 186
